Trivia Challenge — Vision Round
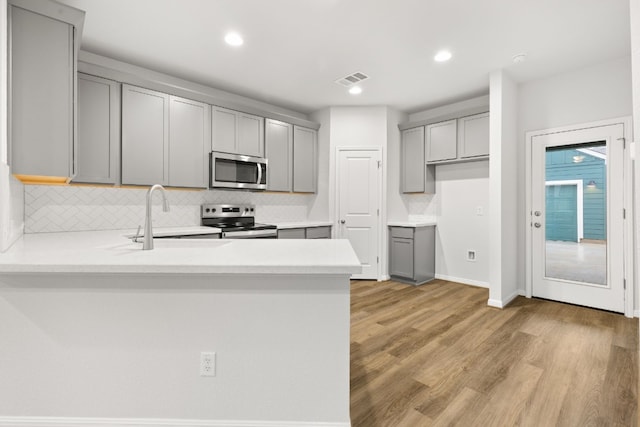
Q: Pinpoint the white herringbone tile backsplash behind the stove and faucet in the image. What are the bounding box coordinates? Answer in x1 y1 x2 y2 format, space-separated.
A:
24 185 315 233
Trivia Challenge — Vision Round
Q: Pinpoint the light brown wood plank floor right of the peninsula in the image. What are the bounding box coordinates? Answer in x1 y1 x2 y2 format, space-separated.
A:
351 280 638 427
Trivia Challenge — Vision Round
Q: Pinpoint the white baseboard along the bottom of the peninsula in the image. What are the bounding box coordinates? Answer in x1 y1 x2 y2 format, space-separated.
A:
0 417 351 427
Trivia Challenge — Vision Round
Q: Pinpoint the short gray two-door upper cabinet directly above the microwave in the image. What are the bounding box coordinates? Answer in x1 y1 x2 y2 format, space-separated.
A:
211 106 264 157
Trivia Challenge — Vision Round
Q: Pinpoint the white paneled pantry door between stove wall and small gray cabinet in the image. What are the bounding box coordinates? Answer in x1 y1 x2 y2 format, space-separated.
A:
336 150 381 279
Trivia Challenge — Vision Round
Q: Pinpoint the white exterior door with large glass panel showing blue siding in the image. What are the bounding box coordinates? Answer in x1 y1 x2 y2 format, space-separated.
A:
530 124 624 313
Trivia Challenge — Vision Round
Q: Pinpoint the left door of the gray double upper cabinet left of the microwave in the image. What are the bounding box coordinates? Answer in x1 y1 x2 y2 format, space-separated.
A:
122 85 169 185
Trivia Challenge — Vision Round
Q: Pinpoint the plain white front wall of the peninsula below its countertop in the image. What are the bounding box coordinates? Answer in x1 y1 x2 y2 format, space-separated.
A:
0 274 349 427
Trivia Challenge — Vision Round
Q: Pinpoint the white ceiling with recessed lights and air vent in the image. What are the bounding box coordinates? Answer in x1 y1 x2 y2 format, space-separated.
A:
59 0 630 113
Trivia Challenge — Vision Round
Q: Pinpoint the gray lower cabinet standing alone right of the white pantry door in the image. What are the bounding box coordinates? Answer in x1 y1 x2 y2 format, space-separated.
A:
389 226 435 285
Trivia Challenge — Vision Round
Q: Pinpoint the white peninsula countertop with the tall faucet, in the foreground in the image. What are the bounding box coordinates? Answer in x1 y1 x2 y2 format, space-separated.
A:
0 228 362 275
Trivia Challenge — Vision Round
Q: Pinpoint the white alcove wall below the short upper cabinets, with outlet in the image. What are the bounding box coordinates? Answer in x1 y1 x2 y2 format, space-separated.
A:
436 160 491 287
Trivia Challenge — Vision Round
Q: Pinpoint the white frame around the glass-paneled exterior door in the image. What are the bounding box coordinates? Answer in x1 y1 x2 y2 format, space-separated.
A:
525 117 636 317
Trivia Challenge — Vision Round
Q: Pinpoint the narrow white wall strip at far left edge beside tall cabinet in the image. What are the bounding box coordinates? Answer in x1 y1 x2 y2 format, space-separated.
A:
0 0 24 252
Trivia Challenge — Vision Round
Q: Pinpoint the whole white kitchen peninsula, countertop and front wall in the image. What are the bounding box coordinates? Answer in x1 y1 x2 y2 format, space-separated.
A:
0 231 361 426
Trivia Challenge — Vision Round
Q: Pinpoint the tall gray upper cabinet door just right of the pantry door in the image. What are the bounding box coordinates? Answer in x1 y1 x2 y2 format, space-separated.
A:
400 126 425 193
